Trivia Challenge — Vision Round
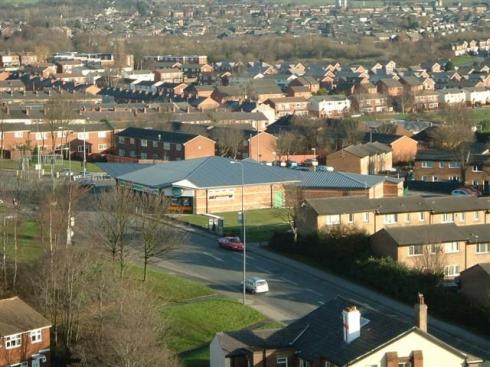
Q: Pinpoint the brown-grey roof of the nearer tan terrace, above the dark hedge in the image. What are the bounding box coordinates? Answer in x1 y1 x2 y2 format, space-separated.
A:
381 223 467 246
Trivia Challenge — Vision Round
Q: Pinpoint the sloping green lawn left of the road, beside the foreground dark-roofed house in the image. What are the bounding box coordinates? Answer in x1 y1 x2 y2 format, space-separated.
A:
127 264 276 367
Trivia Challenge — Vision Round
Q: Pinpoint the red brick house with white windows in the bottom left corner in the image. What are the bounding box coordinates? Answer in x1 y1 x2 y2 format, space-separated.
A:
0 297 51 367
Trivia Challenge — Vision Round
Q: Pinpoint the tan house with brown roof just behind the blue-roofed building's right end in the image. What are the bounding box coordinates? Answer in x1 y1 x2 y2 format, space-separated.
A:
327 142 393 175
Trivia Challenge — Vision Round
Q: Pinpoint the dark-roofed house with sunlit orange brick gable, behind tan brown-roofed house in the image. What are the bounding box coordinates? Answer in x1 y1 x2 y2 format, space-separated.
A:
362 132 417 164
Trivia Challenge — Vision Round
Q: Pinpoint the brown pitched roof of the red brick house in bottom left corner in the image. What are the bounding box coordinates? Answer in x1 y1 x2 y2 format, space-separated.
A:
0 297 51 336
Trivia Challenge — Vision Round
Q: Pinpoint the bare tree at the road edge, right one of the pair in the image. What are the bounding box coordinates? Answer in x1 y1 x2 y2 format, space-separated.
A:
136 194 185 281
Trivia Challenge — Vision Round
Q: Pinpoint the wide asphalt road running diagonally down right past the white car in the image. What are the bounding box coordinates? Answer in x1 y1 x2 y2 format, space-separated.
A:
157 227 490 360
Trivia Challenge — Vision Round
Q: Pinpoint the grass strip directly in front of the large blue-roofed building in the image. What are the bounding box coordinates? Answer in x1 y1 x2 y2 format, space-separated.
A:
178 209 289 242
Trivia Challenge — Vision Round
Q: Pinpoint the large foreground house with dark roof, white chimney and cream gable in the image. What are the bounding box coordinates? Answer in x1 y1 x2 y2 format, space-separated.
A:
209 294 482 367
